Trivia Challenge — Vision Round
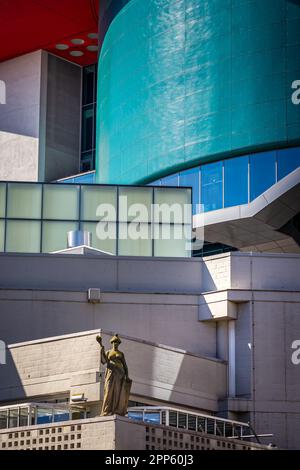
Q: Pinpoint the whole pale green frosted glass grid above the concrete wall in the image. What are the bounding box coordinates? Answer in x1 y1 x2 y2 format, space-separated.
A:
0 182 192 257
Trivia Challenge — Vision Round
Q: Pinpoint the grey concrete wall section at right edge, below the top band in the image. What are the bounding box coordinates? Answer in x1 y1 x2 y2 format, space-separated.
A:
220 290 300 449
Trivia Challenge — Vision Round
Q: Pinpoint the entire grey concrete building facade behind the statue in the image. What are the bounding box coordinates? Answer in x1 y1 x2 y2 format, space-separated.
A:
0 253 300 448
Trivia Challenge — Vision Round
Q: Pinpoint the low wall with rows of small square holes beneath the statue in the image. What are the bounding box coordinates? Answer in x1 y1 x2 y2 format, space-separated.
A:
0 416 266 452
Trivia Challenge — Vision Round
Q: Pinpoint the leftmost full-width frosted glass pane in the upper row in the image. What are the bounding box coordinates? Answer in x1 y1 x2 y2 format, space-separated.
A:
7 183 42 219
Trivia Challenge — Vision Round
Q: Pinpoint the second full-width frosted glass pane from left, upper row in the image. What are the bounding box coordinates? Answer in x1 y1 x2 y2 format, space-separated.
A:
43 184 79 220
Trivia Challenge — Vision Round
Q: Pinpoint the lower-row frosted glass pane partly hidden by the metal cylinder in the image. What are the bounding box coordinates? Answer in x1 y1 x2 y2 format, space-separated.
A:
42 222 78 253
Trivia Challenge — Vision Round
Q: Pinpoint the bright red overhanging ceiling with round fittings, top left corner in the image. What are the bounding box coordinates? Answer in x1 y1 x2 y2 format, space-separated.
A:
0 0 98 65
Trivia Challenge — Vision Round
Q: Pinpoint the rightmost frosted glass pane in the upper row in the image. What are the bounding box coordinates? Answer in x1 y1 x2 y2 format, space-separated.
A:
154 188 192 224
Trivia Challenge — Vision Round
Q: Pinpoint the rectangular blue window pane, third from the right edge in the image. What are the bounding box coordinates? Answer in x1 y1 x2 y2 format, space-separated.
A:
224 156 249 207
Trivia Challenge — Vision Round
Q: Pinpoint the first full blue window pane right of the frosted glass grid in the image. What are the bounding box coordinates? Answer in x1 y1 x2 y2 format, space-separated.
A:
201 162 223 212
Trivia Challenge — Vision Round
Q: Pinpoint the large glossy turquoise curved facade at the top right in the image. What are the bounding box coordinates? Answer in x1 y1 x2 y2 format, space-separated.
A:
96 0 300 184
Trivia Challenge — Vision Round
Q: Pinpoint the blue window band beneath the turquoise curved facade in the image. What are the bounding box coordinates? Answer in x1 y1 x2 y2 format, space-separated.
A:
153 147 300 214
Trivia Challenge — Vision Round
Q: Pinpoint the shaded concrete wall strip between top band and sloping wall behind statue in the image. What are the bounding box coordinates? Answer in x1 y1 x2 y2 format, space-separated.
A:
0 290 216 357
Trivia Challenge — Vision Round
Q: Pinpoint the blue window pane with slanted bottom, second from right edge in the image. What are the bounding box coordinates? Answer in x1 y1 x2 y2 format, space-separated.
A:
250 152 276 201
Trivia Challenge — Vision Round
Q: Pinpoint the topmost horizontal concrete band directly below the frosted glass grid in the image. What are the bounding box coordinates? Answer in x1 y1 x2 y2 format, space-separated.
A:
0 252 300 295
